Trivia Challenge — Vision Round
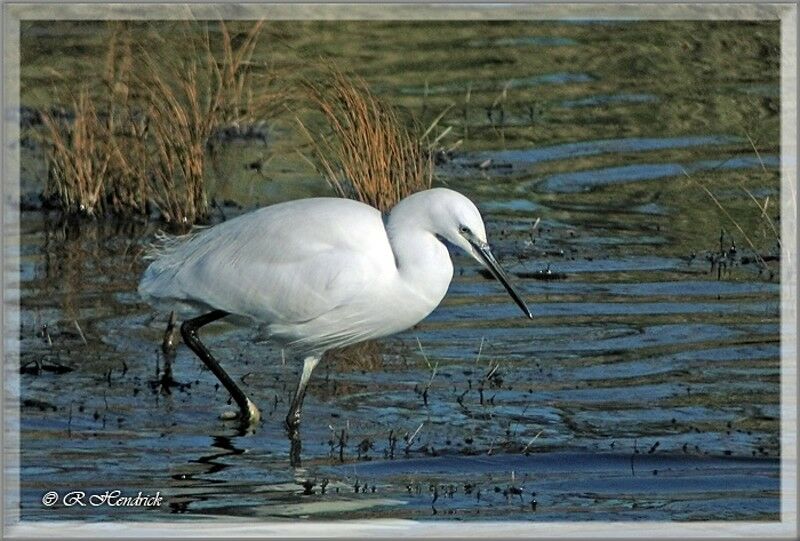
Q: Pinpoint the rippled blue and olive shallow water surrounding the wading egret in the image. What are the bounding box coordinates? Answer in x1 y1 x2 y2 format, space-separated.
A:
20 22 780 521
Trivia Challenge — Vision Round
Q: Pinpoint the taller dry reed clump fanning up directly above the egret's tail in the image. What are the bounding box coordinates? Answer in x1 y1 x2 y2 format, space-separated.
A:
140 21 263 224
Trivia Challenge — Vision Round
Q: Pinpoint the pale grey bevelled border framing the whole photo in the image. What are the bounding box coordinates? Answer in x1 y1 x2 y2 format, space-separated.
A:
0 3 798 539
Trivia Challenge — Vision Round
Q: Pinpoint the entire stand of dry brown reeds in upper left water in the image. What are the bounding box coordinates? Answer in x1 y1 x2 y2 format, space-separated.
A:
45 21 285 226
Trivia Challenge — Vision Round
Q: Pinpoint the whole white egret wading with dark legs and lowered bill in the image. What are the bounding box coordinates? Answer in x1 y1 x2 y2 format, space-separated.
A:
139 188 532 434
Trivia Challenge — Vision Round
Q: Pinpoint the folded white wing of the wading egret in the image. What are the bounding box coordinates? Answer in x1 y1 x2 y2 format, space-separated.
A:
141 199 394 324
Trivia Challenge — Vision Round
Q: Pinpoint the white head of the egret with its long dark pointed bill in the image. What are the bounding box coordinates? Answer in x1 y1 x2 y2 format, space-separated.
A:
418 188 533 319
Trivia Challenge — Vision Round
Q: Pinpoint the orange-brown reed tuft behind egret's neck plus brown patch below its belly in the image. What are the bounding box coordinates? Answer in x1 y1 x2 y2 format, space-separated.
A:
298 64 433 367
